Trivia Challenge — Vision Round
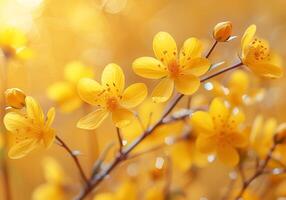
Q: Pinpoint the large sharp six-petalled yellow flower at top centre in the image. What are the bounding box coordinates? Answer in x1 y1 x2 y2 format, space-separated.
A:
133 32 210 102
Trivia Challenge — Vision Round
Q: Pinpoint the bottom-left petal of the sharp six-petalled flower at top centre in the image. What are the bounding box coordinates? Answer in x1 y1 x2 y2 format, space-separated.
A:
152 78 174 103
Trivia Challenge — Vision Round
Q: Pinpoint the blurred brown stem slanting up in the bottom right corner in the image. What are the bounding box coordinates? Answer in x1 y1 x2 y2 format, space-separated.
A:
235 142 279 200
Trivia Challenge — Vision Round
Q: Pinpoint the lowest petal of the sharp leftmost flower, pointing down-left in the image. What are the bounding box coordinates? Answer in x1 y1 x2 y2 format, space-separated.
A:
8 139 38 159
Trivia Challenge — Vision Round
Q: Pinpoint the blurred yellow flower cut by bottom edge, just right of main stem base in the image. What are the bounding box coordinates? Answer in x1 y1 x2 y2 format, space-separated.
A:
93 180 138 200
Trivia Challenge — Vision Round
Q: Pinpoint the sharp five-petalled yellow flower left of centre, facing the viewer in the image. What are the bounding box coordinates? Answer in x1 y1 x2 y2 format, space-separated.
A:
77 64 147 130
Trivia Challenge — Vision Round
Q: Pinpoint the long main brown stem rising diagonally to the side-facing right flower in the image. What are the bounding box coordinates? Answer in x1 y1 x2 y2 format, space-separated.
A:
75 62 242 200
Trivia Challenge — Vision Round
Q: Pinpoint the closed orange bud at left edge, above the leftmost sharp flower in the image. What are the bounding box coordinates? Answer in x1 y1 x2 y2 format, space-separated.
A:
5 88 26 109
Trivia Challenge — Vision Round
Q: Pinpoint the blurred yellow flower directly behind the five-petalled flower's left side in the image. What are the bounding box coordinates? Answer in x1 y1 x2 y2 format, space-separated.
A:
47 61 94 113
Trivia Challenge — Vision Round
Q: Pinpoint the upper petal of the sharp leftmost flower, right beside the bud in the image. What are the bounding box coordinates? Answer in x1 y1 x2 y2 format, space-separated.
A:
25 96 44 124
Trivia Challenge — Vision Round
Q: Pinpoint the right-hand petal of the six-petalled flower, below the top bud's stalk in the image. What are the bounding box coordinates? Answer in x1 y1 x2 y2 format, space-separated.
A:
184 58 211 76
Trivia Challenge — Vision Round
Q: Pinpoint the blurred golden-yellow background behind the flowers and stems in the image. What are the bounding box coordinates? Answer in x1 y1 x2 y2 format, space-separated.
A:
0 0 286 200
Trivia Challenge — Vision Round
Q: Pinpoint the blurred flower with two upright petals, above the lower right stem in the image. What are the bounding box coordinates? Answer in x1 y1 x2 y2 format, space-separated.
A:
249 115 277 158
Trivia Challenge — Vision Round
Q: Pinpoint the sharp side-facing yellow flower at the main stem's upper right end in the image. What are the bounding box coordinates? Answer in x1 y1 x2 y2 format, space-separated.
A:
241 25 283 78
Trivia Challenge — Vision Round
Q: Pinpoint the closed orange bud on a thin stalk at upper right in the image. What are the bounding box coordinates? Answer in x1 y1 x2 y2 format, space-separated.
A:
213 21 232 42
